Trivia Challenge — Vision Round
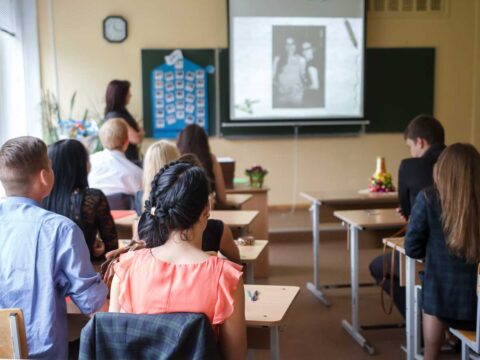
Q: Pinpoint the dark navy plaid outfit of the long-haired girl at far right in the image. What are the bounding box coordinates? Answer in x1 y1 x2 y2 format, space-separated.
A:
405 187 477 322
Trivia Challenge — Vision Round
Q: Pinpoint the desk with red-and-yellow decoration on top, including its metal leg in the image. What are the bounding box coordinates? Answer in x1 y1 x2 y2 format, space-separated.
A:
300 190 398 307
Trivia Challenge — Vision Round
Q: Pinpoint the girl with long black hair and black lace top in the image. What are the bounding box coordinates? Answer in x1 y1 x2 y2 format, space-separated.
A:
43 140 118 259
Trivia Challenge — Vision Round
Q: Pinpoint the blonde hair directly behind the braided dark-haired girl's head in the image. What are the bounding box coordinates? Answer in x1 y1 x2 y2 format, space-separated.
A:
142 140 180 208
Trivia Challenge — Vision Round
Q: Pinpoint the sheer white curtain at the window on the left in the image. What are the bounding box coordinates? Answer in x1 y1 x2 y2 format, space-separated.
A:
0 0 41 144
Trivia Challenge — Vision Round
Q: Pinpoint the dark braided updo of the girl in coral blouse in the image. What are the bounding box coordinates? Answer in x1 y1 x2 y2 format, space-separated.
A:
138 161 210 248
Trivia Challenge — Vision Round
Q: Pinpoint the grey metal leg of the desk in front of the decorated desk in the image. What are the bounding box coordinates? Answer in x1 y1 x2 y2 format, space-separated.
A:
342 225 375 355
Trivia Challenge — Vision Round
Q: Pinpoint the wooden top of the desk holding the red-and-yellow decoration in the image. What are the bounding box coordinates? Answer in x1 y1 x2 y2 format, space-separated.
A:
300 190 398 205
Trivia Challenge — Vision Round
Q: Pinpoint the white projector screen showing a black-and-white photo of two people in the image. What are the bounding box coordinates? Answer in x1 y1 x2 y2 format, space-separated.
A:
229 0 365 120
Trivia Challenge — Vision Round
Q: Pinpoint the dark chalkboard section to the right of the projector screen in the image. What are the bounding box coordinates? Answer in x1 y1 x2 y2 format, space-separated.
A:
365 48 435 133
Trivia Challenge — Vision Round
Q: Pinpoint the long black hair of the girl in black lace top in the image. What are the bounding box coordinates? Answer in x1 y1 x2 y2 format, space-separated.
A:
43 140 88 220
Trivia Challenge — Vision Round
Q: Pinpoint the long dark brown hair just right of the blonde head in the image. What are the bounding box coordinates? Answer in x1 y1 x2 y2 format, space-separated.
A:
177 124 215 184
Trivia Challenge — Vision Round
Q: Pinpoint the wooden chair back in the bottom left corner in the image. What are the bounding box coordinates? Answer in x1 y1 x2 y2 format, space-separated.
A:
0 309 28 359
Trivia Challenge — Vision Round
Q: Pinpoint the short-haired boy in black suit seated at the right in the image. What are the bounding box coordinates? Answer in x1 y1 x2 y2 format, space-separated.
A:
369 115 445 317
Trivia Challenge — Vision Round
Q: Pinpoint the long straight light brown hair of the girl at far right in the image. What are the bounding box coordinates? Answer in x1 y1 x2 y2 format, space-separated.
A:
433 143 480 263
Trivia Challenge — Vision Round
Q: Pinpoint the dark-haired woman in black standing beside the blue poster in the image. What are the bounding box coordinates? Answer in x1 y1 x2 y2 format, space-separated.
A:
105 80 144 165
